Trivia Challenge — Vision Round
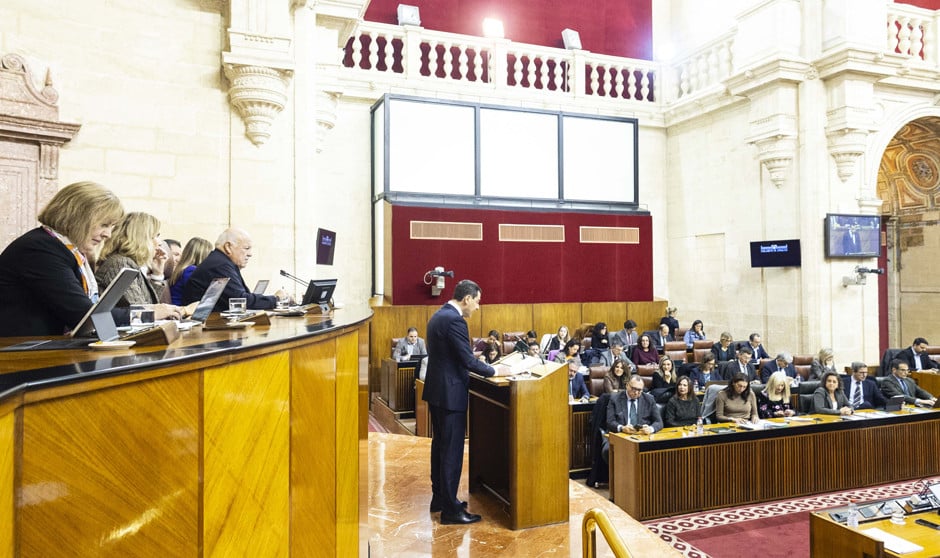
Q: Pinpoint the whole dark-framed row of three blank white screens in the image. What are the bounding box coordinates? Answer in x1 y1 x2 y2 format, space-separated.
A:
372 94 638 206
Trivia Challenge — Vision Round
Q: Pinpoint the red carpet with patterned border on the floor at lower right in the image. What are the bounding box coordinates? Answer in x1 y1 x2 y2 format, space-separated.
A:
644 477 940 558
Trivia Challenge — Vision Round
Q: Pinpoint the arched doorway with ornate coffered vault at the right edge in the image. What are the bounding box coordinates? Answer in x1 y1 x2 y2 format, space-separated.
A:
877 116 940 347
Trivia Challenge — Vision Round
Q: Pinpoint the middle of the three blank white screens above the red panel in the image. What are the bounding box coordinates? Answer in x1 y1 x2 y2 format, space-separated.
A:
480 108 558 200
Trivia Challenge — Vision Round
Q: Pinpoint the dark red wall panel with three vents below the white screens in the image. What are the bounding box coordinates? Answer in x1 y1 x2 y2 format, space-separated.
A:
386 205 653 305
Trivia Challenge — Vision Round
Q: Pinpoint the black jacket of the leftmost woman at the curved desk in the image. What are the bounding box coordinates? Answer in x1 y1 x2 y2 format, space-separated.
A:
0 227 128 337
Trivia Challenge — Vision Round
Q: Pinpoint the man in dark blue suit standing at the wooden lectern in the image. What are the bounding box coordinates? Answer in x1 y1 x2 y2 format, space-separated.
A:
423 279 506 525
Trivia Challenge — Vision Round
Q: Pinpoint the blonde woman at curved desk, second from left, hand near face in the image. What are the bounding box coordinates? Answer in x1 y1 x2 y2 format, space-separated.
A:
95 212 183 320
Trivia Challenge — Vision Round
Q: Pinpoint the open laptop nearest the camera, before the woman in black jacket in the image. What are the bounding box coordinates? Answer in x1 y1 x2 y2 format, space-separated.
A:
3 267 140 351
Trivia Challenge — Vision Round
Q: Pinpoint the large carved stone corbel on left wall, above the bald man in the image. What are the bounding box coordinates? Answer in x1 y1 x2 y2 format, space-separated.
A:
224 62 293 145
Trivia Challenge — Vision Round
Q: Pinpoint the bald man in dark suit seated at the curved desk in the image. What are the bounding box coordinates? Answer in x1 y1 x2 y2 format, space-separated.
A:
183 228 287 312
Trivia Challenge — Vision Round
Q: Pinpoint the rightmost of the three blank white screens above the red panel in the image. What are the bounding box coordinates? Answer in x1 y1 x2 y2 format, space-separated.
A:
562 115 637 203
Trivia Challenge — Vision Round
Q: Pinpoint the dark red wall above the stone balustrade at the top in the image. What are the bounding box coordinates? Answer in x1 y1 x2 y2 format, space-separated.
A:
365 0 653 60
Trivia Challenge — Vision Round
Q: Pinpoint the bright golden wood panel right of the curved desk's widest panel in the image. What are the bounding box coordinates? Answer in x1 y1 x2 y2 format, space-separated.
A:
203 352 290 556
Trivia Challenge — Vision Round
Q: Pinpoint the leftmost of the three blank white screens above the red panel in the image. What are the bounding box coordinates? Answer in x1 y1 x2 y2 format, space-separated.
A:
387 98 476 196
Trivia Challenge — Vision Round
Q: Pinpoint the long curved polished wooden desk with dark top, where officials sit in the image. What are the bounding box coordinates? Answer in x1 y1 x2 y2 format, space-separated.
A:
0 307 372 557
